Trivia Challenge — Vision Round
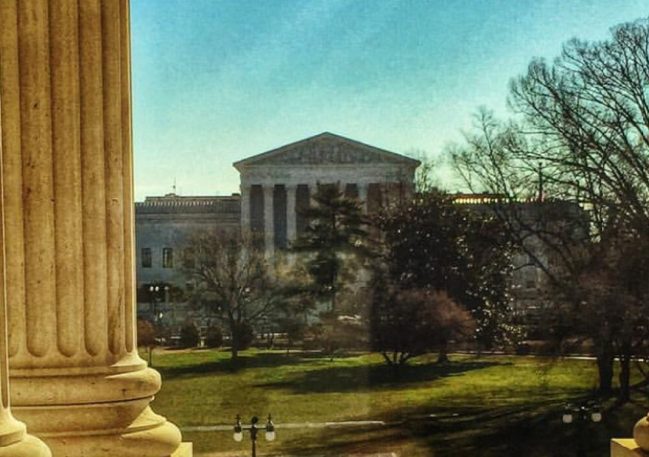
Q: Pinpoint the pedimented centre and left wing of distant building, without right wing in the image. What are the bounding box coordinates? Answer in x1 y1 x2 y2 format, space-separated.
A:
135 133 420 324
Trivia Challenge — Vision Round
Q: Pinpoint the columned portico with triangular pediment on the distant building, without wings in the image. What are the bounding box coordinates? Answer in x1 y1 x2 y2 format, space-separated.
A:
234 132 420 255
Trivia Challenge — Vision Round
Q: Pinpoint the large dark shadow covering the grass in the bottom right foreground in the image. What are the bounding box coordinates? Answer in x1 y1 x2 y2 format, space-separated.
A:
282 391 612 457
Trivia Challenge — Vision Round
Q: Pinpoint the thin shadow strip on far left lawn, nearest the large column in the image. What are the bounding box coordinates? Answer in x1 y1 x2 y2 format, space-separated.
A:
156 352 360 379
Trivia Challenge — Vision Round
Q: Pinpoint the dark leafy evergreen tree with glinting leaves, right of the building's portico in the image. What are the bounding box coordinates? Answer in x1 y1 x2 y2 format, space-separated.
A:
374 190 517 349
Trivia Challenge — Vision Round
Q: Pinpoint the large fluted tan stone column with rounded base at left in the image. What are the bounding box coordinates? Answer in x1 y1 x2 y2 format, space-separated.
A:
0 0 185 457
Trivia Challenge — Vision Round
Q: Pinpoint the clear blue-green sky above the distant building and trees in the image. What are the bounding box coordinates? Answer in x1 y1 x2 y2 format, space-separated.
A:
131 0 649 200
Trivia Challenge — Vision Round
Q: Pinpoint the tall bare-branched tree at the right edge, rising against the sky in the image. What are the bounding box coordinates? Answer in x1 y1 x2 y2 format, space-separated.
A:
451 20 649 399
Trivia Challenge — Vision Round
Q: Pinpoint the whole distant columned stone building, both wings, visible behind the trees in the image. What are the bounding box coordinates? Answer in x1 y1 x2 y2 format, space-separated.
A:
135 133 588 332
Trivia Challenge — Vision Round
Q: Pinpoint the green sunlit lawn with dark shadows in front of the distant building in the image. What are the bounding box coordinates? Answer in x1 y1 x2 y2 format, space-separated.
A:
148 350 647 457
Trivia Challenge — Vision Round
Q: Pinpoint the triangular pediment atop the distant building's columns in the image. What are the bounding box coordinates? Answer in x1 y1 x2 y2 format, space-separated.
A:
234 132 419 169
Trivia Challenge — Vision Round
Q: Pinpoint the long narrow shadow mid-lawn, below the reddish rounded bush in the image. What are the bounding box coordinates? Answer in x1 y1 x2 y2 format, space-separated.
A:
255 360 502 393
